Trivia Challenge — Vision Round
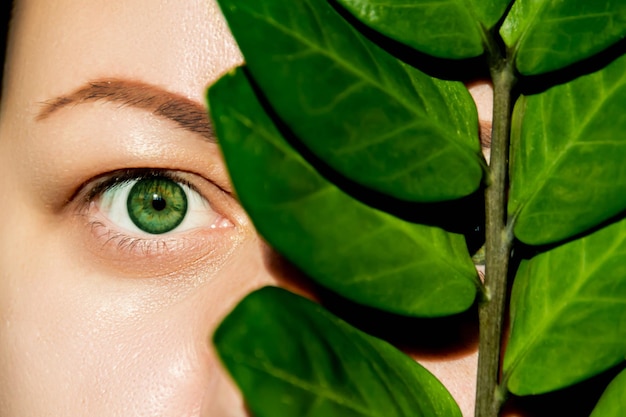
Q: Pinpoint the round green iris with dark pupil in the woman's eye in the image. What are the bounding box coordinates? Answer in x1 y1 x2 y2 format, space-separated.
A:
126 177 187 235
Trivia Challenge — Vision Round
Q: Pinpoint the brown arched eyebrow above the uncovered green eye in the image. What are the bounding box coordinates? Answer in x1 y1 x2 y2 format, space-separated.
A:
36 78 216 143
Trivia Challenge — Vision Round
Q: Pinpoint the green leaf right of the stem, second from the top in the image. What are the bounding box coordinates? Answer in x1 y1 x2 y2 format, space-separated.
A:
509 52 626 244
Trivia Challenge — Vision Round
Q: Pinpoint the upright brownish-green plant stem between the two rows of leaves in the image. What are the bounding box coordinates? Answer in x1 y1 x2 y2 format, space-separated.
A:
475 58 515 417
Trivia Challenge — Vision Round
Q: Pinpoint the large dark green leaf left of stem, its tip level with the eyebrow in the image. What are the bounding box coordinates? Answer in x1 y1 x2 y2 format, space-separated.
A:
214 0 483 202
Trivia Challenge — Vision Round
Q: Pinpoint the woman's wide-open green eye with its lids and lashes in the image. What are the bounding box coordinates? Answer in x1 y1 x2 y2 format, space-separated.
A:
78 169 234 257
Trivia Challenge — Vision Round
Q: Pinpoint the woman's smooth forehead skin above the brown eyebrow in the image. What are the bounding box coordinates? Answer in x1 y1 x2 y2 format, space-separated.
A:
6 0 240 112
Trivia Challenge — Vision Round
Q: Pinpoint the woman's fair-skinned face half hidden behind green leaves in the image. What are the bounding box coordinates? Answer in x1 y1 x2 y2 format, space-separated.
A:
0 0 488 417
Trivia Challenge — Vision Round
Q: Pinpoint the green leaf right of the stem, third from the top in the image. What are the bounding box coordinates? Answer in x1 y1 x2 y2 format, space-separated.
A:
504 213 626 395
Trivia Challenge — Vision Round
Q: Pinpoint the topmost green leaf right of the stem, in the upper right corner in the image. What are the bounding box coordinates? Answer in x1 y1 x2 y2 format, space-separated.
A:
500 0 626 75
